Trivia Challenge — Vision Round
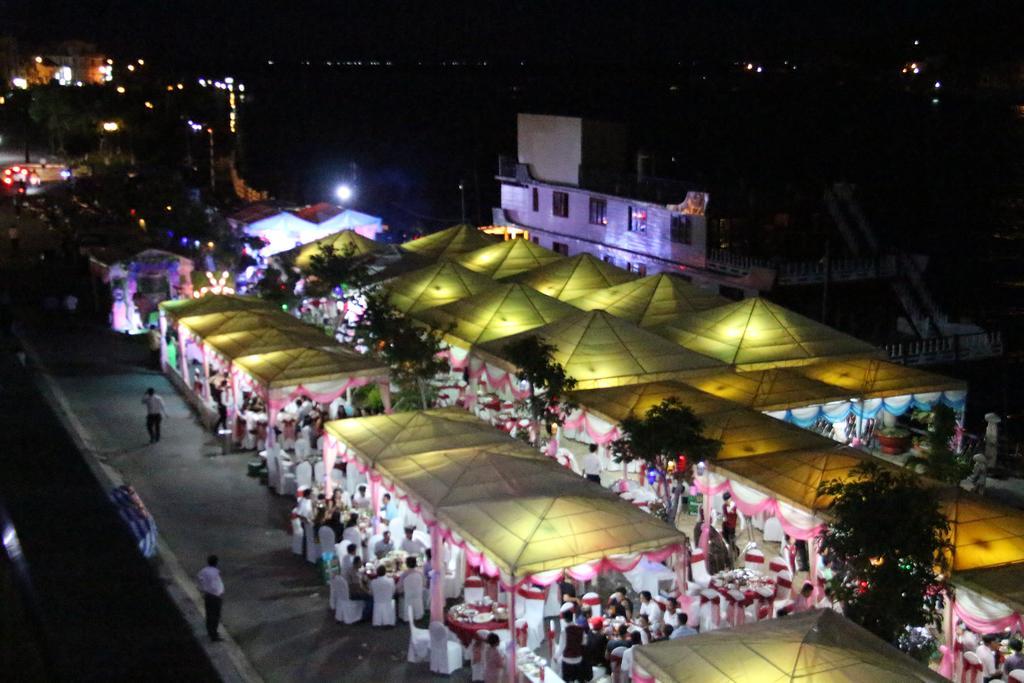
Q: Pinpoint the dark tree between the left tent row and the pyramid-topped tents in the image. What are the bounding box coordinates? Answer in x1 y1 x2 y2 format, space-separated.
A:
356 292 449 410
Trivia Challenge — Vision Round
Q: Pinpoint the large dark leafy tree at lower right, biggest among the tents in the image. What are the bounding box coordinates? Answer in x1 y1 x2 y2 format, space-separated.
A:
818 463 952 643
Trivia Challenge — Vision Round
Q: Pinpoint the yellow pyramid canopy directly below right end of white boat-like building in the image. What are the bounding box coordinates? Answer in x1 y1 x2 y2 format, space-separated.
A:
569 272 728 328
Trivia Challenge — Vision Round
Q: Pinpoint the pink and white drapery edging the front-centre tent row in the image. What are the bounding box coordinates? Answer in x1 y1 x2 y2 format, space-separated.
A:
324 434 683 590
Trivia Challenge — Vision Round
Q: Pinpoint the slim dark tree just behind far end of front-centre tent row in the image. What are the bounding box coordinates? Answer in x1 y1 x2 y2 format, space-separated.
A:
504 335 577 445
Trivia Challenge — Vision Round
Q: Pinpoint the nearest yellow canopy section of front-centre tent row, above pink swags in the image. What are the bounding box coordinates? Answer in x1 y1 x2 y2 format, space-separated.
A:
435 491 686 578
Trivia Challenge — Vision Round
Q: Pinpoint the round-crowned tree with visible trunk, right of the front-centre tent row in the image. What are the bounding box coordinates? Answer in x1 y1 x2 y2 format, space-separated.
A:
611 396 722 519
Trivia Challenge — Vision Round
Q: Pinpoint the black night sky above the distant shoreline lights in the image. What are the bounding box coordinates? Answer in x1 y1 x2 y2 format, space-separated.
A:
0 0 1024 67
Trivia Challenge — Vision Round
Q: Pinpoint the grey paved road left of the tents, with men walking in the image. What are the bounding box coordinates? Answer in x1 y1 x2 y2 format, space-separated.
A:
23 313 469 681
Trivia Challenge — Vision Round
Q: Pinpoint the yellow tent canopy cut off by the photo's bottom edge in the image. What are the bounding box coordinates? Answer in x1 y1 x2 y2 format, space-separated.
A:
634 609 946 683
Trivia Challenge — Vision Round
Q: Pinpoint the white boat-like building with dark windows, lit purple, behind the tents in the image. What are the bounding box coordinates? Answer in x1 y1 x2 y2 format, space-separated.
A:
495 114 753 292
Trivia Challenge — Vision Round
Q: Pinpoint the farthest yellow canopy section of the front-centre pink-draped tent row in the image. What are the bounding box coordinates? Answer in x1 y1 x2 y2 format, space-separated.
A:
325 409 513 464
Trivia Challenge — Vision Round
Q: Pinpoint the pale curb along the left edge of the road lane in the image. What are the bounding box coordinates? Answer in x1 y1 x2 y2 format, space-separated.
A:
15 332 263 683
